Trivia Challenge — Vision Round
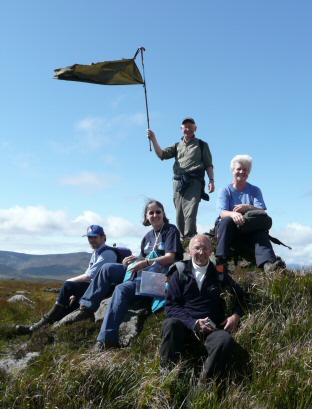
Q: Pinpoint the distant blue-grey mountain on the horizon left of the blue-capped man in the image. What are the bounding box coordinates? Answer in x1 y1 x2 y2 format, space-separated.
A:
0 251 91 281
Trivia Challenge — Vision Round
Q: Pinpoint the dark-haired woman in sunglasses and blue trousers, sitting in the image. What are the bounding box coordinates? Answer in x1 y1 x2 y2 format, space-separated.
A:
67 200 183 351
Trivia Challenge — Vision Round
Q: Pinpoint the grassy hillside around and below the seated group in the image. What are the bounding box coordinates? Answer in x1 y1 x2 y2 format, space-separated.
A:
0 268 312 409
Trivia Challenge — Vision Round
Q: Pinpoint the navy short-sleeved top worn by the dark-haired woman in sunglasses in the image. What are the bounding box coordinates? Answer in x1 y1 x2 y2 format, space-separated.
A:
140 223 183 260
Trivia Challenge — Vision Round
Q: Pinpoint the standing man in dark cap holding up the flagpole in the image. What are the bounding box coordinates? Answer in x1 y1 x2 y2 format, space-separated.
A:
147 118 215 240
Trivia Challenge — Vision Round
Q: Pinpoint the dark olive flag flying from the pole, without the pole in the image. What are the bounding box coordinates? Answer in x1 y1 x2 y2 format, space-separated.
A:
54 59 144 85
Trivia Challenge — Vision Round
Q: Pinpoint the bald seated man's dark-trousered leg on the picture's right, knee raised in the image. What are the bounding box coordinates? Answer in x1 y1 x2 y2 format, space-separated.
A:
202 330 234 379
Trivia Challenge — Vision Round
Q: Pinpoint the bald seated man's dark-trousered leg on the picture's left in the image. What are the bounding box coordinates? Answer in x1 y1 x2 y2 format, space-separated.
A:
160 318 191 367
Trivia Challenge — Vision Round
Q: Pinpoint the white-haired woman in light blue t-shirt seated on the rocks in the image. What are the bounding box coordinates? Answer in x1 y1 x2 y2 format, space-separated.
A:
216 155 285 272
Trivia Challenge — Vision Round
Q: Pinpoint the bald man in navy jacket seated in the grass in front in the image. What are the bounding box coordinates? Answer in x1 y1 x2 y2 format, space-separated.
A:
160 235 247 380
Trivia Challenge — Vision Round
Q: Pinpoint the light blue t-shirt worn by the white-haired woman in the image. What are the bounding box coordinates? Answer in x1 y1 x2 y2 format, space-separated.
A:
217 183 266 214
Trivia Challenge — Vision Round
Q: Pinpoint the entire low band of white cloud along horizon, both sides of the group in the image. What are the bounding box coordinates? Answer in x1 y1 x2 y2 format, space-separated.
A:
0 205 312 266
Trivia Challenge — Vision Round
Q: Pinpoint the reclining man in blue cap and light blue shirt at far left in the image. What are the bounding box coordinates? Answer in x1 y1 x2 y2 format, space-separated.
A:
16 225 117 335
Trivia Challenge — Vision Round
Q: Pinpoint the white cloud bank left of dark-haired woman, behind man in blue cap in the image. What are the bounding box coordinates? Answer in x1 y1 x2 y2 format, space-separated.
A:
0 205 146 254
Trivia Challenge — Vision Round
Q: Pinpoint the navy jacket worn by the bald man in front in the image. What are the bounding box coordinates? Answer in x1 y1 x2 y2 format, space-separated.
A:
166 260 247 331
